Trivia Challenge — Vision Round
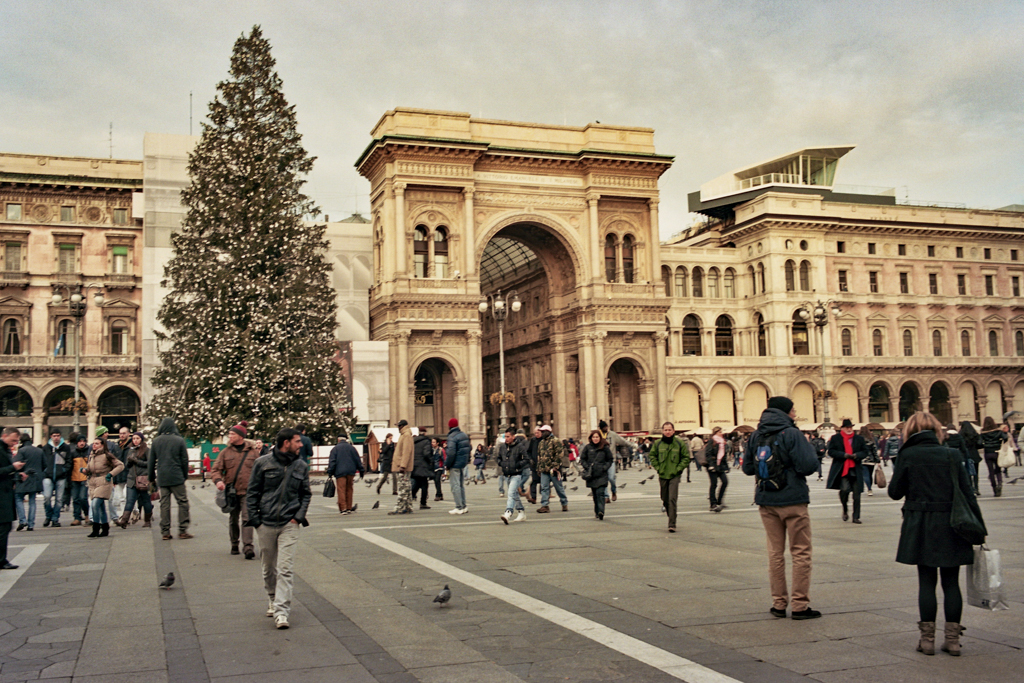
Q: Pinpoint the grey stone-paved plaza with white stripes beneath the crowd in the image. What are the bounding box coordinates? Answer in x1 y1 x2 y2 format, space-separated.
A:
0 470 1024 683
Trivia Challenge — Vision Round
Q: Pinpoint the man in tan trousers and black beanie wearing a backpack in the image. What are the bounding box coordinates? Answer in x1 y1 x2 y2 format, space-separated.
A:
743 396 821 620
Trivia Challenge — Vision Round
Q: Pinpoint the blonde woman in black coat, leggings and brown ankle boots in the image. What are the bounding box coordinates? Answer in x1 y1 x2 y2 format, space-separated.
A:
889 413 981 656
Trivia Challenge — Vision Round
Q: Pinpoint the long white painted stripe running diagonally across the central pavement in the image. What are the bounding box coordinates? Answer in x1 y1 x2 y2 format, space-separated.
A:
345 528 740 683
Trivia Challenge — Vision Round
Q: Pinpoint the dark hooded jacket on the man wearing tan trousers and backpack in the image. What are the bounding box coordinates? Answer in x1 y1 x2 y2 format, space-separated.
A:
743 408 818 508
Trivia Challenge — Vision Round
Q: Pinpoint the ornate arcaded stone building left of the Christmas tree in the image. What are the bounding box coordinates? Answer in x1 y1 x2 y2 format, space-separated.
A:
0 154 142 442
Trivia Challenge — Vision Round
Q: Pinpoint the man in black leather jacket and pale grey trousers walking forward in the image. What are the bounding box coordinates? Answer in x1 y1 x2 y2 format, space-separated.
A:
246 429 312 629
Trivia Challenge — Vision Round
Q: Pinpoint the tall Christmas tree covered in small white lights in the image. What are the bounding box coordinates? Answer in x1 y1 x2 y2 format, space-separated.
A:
146 27 352 439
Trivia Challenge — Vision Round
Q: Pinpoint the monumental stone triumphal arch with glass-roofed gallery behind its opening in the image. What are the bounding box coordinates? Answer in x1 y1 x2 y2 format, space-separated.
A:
356 109 673 439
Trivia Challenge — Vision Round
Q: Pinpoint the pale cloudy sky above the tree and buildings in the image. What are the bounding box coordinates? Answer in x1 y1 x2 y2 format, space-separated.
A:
0 0 1024 238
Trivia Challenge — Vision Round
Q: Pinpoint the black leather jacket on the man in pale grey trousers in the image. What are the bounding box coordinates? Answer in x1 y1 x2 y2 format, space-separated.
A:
246 449 313 527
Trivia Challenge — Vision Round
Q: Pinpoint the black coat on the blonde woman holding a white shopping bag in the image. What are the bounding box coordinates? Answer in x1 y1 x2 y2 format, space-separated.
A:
889 431 982 567
